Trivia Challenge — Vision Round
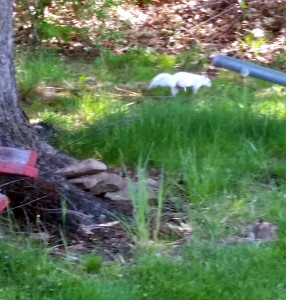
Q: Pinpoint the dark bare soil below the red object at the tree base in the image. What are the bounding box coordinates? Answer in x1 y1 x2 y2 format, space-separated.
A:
0 175 134 260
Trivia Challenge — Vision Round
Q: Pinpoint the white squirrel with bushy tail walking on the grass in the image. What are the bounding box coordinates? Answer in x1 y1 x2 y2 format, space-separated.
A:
147 72 212 96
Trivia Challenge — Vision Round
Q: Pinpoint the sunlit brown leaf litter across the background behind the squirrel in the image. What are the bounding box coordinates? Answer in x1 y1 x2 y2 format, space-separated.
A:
15 0 286 63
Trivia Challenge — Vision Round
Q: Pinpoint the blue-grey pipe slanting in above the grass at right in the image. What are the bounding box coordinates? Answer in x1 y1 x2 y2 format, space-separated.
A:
213 54 286 86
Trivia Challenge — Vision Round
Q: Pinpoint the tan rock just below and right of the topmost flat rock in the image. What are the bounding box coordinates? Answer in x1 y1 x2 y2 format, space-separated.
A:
90 173 126 195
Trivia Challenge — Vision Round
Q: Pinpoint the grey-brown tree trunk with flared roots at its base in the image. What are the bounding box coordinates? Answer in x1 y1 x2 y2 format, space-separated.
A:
0 0 122 233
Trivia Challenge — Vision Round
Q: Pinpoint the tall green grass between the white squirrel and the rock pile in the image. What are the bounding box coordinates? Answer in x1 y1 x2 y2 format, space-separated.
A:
16 49 286 231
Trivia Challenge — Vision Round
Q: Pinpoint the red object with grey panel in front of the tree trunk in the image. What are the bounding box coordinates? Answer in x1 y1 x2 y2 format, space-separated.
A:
0 147 39 178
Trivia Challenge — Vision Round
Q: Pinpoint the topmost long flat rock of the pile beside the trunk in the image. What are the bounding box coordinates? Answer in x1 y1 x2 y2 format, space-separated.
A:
60 158 107 178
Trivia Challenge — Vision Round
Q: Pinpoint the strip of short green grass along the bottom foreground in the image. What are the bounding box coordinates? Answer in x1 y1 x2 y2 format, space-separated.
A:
0 240 286 300
